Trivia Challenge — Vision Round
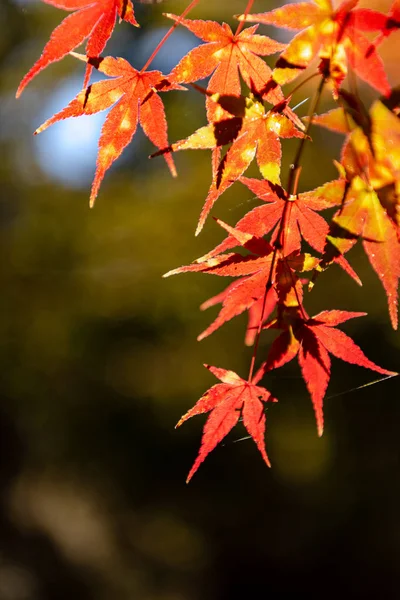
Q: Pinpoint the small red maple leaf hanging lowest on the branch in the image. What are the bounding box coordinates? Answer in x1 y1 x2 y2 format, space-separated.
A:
176 365 277 483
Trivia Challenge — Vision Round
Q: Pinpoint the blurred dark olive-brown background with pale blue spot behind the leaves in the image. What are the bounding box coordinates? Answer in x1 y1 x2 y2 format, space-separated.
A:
0 0 400 600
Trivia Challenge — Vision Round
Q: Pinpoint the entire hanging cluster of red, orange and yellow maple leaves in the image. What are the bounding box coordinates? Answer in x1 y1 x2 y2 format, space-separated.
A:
17 0 400 479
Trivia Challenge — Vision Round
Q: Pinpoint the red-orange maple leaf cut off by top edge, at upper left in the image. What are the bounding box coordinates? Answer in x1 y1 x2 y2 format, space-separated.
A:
16 0 139 98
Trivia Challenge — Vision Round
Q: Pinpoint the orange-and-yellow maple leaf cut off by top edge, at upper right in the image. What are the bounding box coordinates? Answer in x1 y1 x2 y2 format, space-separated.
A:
239 0 390 95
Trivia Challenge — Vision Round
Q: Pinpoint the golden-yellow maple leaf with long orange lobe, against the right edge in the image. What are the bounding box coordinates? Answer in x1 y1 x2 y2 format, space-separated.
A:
314 101 400 329
